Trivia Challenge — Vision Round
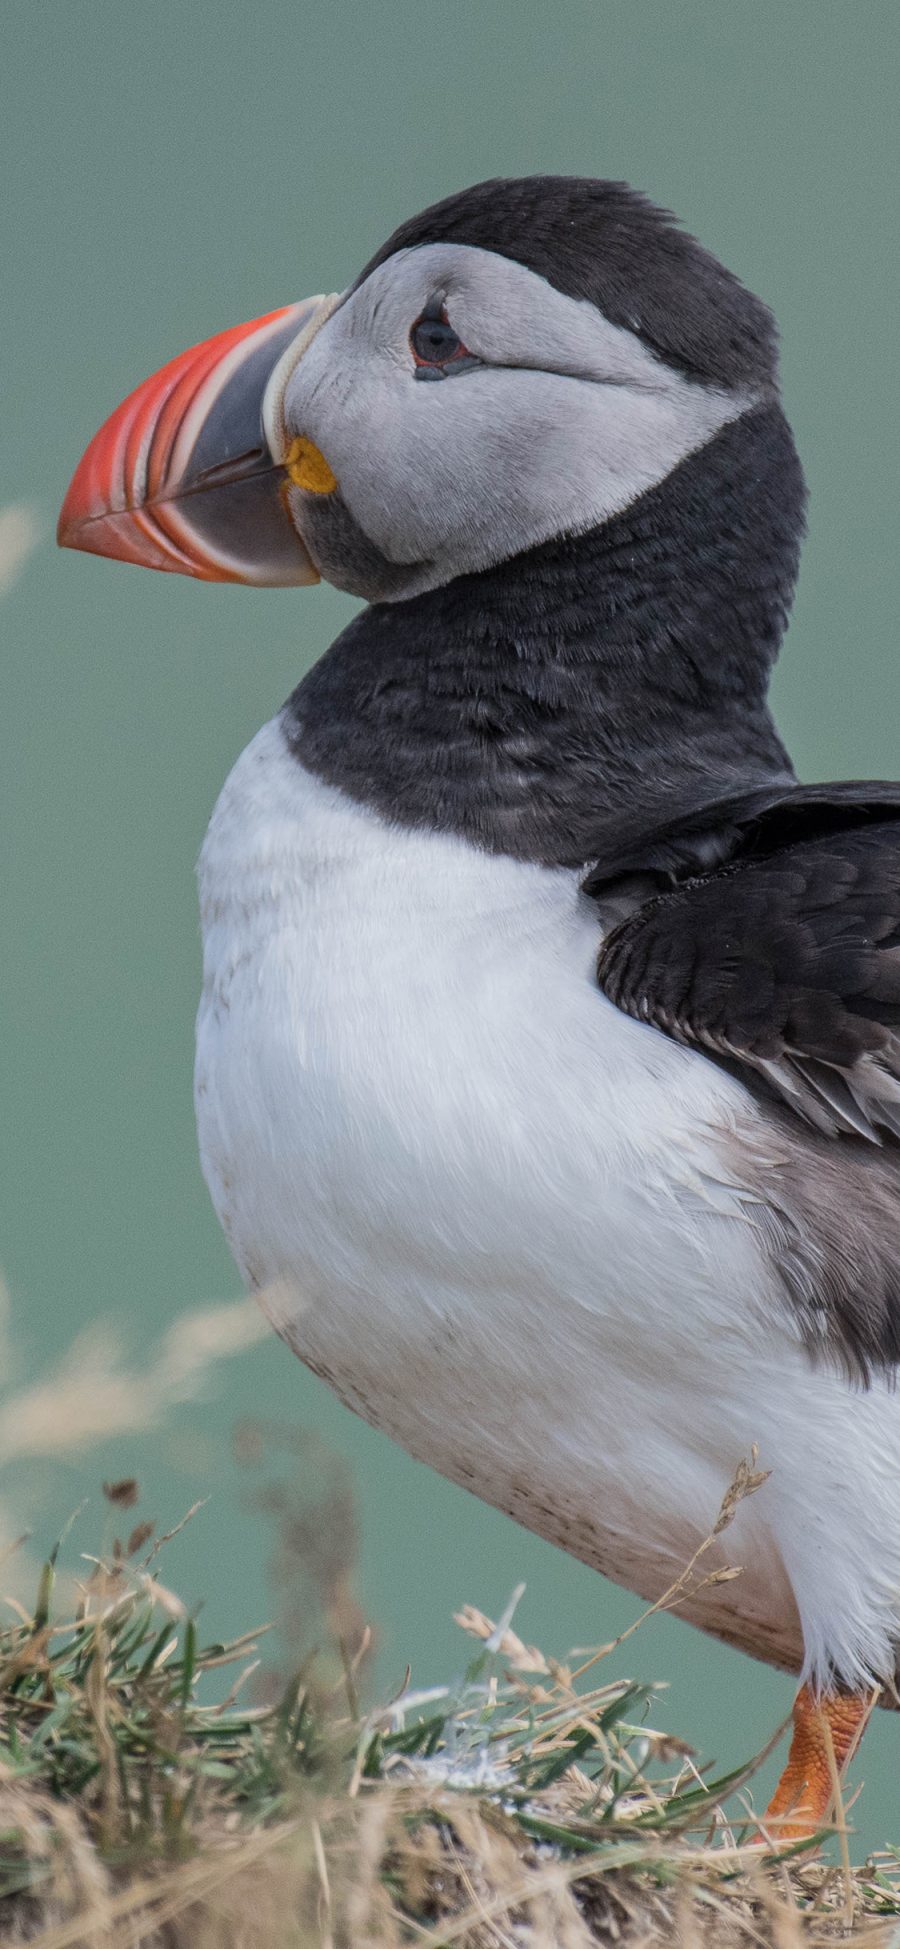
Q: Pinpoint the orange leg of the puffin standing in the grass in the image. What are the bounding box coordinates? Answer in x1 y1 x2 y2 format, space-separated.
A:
766 1686 879 1842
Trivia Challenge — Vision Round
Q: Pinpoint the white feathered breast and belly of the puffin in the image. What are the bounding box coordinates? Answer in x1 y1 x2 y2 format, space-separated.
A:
197 721 900 1691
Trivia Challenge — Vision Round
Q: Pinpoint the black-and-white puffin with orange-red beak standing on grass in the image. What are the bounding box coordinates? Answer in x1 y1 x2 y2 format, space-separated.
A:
58 175 900 1840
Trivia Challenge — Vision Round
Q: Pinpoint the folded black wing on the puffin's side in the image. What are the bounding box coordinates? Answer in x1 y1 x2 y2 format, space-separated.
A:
584 785 900 1142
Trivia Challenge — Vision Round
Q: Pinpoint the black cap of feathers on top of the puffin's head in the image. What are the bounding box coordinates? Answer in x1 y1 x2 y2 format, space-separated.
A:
356 175 777 388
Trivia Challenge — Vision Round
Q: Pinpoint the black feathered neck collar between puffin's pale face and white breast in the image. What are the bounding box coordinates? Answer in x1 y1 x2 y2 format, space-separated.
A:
284 405 803 865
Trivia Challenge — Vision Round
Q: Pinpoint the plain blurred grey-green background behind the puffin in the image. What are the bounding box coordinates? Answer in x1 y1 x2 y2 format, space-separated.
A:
0 0 900 1846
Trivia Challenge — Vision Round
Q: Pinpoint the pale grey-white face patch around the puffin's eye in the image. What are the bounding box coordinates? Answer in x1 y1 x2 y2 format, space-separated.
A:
282 244 756 598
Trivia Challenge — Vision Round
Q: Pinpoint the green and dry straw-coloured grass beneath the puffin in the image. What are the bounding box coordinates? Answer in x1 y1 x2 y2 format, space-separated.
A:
0 1483 900 1949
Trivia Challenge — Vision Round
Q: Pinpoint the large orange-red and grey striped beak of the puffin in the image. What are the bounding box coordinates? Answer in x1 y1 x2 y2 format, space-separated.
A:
56 296 337 585
